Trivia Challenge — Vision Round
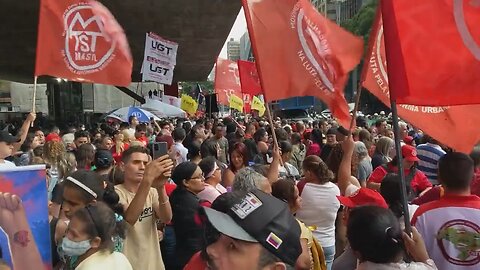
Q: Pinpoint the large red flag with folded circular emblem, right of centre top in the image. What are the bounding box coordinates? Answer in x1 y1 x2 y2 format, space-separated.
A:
242 0 363 126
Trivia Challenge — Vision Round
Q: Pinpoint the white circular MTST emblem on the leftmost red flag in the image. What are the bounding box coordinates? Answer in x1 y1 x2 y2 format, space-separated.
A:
63 2 115 74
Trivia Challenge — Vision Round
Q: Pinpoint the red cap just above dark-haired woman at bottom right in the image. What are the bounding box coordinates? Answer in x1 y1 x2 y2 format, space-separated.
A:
337 187 388 209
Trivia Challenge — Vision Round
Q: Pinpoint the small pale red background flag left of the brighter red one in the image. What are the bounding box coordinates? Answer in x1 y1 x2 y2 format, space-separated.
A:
215 58 242 105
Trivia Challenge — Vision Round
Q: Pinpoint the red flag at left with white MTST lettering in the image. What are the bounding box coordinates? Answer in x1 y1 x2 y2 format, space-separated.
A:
35 0 133 86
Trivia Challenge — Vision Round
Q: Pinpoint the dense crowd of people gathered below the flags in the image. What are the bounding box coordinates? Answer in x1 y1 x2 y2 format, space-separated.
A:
0 114 480 270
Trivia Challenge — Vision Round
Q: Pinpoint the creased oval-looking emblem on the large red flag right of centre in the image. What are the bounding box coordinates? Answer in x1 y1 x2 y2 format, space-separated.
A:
290 4 338 93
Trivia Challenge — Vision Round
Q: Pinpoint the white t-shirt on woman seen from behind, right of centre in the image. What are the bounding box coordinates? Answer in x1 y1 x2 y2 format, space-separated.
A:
297 182 340 247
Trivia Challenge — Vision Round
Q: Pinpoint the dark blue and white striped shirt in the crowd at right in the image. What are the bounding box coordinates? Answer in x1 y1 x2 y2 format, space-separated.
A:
417 143 446 185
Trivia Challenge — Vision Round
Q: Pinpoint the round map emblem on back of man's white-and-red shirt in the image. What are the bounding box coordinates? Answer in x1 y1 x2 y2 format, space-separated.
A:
437 219 480 266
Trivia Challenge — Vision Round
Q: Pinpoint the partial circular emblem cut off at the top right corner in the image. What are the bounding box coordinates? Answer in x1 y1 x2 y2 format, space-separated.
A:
453 0 480 61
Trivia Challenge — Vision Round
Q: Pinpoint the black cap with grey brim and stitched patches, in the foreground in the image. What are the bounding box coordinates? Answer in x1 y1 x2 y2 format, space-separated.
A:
204 190 302 266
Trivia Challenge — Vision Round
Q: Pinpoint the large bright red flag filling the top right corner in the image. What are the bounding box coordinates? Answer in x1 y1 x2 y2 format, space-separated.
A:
382 0 480 106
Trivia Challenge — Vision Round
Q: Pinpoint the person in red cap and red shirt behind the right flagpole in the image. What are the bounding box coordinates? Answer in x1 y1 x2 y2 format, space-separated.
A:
367 145 432 195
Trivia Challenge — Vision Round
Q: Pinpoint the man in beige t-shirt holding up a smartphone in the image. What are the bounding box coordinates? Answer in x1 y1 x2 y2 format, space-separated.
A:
115 146 173 270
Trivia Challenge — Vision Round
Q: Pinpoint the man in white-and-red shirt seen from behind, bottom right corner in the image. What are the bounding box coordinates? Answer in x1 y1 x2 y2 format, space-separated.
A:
412 152 480 270
